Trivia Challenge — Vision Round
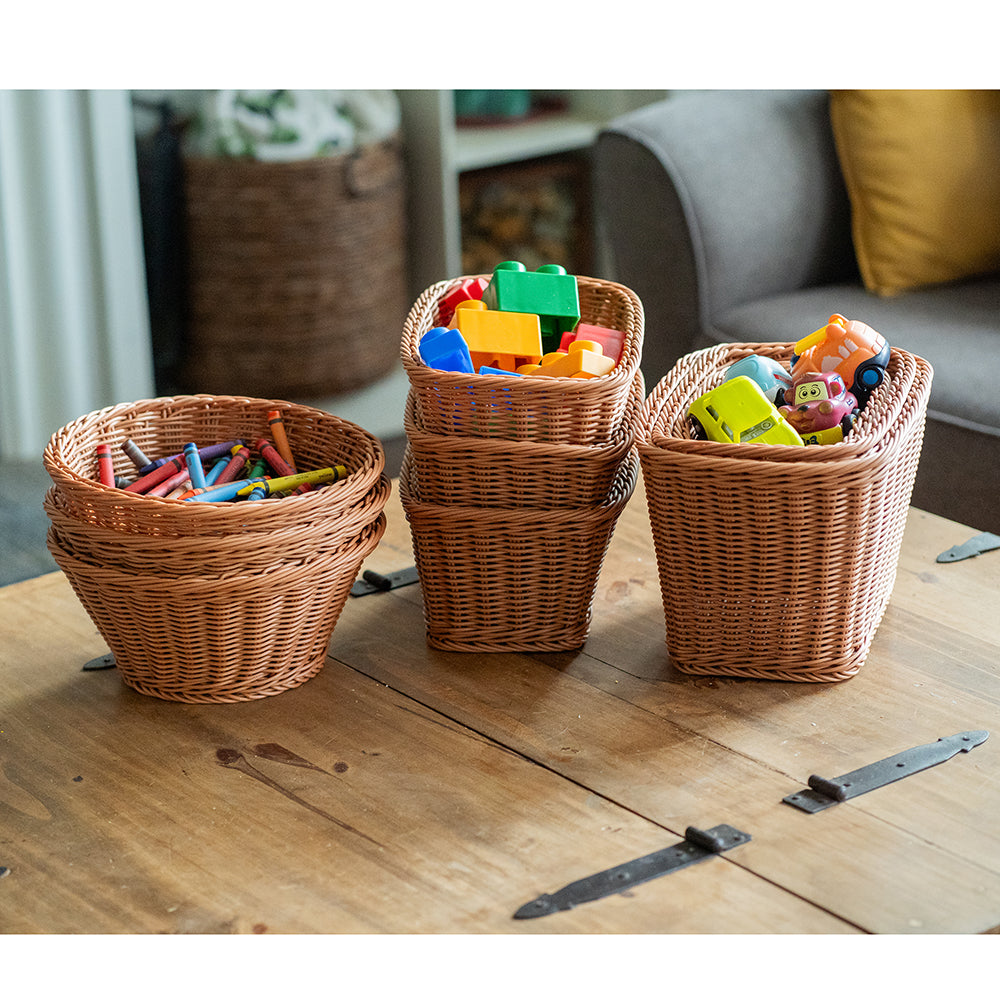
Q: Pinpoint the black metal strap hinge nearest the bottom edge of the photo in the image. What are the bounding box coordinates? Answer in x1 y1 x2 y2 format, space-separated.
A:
514 823 750 920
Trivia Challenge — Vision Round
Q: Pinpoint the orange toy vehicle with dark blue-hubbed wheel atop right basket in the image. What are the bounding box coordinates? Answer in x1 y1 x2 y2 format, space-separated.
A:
792 313 889 407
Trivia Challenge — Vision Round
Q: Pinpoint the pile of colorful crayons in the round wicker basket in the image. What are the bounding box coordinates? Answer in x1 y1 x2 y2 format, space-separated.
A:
96 410 347 503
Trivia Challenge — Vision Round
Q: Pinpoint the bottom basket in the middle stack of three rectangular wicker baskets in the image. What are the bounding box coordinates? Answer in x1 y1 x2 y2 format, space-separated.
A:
399 446 639 652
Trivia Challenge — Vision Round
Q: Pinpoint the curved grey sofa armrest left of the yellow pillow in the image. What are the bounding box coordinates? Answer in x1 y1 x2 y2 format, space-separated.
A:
593 90 857 385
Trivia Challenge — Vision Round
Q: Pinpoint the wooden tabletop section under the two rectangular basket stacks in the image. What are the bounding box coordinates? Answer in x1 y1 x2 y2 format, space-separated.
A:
331 482 1000 933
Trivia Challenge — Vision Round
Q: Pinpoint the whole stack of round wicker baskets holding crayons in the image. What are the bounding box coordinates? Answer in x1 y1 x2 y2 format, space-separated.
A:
44 396 389 702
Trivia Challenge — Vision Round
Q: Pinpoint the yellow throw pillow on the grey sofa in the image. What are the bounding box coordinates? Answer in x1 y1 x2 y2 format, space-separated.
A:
830 90 1000 295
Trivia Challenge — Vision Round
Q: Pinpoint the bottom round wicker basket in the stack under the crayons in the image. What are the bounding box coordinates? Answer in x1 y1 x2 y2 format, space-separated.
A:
49 514 385 703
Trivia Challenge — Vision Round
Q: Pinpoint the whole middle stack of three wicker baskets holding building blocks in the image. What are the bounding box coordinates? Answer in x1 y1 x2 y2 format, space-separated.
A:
399 277 644 652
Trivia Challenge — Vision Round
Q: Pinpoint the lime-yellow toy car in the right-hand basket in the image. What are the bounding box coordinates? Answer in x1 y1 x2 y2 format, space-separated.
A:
688 375 802 445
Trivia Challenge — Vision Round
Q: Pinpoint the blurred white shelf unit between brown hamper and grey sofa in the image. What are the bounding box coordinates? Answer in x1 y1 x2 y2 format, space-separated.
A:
398 90 667 296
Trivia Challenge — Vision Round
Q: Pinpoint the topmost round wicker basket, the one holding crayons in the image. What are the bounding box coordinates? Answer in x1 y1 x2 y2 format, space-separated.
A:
42 395 385 537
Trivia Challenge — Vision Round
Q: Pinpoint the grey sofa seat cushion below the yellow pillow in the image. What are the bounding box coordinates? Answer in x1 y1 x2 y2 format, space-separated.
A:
699 276 1000 437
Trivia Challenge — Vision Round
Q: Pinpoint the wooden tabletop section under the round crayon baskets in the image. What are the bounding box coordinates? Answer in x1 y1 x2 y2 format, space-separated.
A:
0 574 855 934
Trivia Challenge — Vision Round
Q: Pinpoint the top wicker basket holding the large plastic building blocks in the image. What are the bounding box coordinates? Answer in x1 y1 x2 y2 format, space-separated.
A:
400 277 643 445
